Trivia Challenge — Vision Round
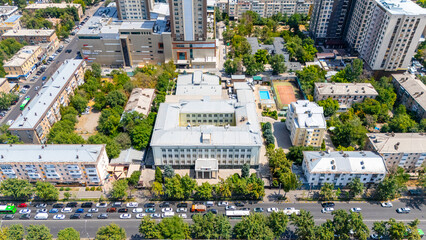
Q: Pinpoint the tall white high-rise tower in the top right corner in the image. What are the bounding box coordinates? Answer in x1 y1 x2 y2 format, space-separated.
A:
358 0 426 71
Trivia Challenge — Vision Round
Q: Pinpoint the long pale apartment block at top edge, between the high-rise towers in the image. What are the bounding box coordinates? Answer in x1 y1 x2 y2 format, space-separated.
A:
226 0 313 19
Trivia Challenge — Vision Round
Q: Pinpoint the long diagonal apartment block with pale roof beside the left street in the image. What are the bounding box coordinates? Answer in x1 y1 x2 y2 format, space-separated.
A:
9 59 86 144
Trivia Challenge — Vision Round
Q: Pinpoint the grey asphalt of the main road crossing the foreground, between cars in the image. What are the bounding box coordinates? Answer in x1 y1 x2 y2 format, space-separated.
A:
1 199 426 238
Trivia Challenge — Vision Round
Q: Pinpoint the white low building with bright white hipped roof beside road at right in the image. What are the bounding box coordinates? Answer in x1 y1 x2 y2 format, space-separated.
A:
302 151 386 187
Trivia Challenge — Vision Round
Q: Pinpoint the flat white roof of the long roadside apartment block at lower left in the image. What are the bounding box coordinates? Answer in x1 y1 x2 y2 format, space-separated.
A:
0 144 105 163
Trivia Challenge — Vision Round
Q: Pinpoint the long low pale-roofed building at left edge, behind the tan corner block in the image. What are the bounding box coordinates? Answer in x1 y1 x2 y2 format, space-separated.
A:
1 29 58 46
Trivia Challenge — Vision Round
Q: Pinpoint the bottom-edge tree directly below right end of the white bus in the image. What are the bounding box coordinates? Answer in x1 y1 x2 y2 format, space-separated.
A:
233 213 274 240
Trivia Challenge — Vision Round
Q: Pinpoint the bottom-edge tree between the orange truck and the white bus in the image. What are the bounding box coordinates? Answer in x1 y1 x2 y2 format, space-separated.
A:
190 213 232 239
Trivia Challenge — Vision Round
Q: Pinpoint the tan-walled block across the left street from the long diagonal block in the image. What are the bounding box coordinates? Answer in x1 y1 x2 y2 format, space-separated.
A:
3 46 44 80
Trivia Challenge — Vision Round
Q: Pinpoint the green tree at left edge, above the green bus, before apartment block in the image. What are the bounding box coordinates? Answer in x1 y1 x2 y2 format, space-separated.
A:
0 178 34 200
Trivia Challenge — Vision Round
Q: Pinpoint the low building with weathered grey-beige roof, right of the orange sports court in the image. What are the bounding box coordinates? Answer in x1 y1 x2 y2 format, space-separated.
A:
314 82 379 111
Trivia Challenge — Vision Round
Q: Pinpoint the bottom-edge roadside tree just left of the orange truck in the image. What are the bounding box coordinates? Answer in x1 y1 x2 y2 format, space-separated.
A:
158 216 191 239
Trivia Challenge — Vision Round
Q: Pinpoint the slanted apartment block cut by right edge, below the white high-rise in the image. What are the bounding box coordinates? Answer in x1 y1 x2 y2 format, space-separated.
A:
392 73 426 118
